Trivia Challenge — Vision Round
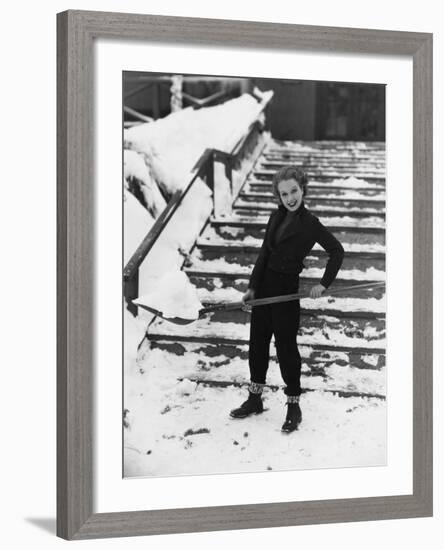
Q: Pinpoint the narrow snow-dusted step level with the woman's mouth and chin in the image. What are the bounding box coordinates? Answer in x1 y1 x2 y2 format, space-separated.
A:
239 190 385 208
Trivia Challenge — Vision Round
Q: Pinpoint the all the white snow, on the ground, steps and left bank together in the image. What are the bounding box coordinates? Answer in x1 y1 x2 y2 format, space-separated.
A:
124 128 387 477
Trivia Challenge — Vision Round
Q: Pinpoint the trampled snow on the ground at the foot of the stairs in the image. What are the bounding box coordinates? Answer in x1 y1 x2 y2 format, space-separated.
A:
124 349 386 477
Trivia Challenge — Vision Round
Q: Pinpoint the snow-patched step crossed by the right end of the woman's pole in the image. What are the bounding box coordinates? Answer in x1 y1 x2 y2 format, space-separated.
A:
185 268 385 302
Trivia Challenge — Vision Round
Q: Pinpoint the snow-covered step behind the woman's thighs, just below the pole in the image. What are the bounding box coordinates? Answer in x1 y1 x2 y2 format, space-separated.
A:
148 316 385 353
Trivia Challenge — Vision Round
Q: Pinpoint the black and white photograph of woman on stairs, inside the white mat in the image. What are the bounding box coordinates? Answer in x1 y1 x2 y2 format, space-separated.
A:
122 71 388 478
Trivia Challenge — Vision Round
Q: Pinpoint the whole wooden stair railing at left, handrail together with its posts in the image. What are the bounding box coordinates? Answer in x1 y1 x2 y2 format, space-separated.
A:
123 95 269 315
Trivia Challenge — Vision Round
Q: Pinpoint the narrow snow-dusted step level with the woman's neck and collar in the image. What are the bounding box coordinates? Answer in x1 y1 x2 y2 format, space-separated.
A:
233 203 385 219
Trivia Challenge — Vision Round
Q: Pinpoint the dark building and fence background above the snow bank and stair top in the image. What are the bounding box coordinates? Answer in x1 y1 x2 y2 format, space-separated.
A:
123 72 385 141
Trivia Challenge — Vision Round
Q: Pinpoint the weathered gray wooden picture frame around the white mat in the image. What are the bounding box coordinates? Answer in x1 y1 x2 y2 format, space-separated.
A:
57 11 433 540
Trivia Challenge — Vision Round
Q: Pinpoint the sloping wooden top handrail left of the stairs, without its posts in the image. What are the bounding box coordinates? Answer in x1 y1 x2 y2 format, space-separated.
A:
123 98 271 282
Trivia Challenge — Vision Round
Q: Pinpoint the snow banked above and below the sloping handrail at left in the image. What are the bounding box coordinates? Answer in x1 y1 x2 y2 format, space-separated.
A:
124 92 272 314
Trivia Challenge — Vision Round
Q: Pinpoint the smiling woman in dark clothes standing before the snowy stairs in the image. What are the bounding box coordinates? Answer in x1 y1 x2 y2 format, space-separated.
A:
230 166 344 432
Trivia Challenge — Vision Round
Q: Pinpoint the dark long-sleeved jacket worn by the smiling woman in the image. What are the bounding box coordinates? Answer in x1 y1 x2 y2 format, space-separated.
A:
249 203 344 290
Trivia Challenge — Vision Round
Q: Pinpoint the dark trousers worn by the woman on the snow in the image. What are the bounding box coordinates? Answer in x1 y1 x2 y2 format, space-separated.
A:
249 269 301 395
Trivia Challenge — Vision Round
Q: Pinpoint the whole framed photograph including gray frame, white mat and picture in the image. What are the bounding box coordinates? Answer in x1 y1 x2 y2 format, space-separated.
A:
57 11 433 540
